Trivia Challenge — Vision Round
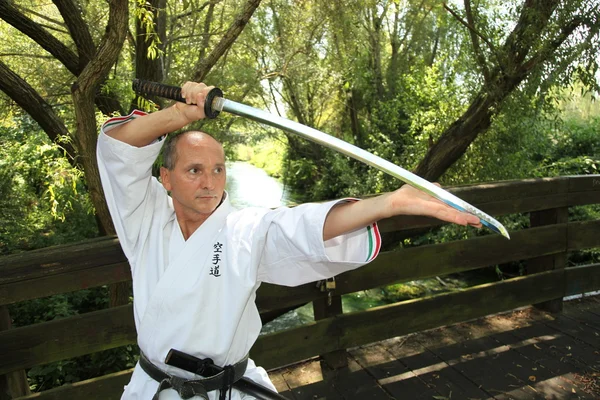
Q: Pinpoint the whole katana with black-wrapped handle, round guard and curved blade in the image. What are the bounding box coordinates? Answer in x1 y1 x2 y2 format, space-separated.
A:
133 79 510 239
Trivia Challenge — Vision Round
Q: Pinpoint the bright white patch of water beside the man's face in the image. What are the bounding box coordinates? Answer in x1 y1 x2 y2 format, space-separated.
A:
227 161 287 209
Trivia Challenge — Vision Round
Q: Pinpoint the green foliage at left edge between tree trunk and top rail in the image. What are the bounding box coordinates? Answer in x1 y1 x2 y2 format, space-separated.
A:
0 116 97 254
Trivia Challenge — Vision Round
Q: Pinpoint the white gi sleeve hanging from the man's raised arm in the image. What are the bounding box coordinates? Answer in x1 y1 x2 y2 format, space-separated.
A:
97 110 166 261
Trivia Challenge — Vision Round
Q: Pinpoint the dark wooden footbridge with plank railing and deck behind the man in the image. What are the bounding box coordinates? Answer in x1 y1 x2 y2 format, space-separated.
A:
0 175 600 400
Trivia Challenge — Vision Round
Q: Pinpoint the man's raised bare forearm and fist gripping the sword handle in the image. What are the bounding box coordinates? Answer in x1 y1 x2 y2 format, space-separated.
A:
106 82 213 147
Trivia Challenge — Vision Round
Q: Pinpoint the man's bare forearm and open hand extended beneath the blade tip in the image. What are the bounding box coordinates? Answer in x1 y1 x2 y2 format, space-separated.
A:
323 185 481 240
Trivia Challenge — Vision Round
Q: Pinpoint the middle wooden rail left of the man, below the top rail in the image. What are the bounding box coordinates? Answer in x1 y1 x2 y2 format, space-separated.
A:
0 305 136 374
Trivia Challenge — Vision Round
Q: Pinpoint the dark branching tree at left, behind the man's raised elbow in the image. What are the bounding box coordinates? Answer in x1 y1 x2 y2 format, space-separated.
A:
0 0 260 305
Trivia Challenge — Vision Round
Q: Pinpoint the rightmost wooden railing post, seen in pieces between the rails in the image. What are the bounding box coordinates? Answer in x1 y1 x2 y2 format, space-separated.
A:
527 207 569 313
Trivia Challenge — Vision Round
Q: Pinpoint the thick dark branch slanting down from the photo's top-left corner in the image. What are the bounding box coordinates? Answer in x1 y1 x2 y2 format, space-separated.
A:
0 0 81 75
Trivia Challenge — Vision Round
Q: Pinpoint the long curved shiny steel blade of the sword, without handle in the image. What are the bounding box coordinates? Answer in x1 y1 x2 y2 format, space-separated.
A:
212 97 510 239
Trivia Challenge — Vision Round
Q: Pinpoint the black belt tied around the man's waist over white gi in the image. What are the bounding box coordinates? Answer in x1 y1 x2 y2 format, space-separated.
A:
139 353 248 400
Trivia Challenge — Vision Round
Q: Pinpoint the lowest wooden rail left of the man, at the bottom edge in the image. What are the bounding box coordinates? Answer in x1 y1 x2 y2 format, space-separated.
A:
15 369 133 400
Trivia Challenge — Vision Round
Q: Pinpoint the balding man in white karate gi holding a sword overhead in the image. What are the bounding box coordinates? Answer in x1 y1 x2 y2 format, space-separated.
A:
98 82 481 400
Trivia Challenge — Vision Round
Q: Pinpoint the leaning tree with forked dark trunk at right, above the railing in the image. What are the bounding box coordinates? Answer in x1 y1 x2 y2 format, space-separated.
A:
416 0 600 180
